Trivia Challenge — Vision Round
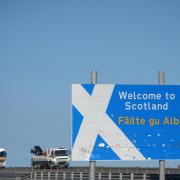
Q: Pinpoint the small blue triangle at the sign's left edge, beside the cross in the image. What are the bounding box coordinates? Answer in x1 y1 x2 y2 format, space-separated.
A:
72 106 83 145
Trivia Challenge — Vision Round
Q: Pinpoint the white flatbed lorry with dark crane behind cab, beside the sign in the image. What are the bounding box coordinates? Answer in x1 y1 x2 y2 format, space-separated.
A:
31 146 70 168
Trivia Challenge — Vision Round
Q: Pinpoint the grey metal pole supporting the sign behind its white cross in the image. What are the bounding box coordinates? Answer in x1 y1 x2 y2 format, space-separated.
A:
89 70 97 180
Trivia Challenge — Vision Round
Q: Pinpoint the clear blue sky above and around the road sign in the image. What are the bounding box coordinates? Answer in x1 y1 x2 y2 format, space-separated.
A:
0 0 180 166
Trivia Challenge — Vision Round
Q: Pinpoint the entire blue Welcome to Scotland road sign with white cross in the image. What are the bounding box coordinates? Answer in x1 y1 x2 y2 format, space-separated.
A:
72 84 180 161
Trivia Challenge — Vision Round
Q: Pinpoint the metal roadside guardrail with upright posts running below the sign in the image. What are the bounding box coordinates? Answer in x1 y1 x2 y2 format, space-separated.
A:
0 167 180 180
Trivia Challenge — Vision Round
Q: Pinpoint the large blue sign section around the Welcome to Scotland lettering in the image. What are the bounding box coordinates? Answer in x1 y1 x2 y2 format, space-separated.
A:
106 85 180 159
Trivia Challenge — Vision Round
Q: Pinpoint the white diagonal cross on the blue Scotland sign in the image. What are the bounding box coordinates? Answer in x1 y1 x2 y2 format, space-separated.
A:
72 84 145 161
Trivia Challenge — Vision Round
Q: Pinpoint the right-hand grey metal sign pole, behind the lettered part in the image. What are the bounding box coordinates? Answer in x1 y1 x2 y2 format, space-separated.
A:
158 71 165 180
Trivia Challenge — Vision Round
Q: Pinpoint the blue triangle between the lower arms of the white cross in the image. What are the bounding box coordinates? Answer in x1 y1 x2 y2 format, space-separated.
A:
90 135 120 160
